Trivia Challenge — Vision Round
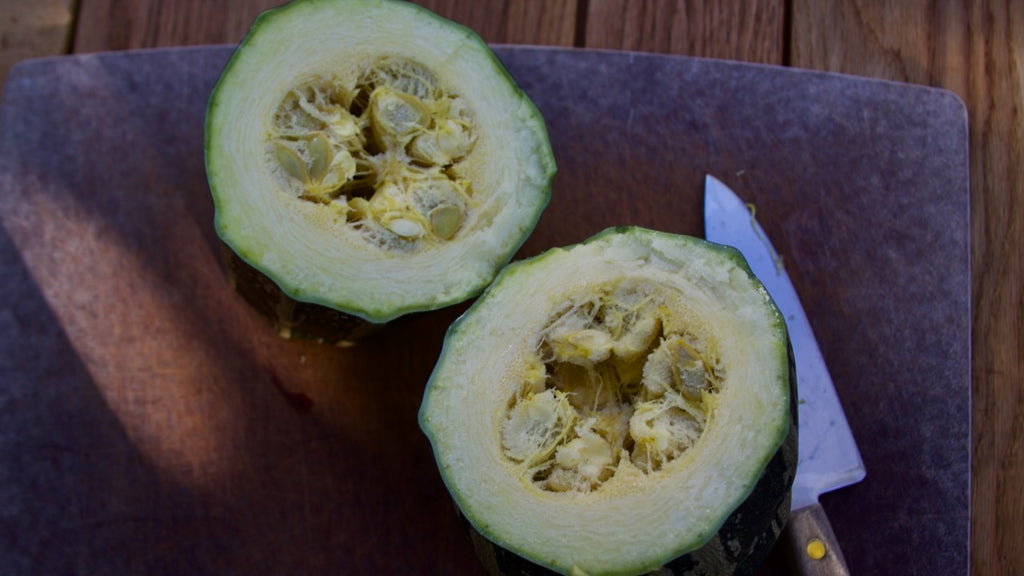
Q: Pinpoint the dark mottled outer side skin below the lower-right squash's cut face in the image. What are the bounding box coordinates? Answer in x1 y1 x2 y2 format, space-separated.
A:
460 347 799 576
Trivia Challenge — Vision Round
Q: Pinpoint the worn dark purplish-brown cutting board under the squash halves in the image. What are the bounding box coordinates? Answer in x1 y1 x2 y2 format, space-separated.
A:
0 47 971 575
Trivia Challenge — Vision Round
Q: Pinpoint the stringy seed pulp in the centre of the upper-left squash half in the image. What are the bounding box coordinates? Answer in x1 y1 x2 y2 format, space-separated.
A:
268 57 475 249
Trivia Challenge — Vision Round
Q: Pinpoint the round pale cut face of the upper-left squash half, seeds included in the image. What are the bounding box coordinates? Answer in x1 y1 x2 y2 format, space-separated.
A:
205 0 555 323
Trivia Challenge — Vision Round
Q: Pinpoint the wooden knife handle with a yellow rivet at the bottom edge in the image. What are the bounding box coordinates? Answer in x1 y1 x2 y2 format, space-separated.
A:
782 502 850 576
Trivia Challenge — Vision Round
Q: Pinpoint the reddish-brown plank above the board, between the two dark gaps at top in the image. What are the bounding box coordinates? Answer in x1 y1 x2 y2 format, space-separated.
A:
584 0 785 64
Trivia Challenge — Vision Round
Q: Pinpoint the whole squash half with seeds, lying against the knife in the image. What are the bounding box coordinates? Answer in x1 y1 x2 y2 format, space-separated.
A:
420 228 797 575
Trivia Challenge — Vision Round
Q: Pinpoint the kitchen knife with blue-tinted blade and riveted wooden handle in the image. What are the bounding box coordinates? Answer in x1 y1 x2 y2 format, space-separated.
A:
705 175 865 575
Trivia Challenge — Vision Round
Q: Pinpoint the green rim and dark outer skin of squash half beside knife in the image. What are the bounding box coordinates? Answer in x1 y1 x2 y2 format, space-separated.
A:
420 227 799 576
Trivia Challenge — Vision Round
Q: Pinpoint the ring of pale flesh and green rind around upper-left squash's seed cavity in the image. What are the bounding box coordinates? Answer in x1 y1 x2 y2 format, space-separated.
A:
205 0 555 323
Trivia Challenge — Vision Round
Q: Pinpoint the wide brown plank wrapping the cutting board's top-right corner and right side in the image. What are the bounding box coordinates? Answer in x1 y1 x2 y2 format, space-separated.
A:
792 0 1024 575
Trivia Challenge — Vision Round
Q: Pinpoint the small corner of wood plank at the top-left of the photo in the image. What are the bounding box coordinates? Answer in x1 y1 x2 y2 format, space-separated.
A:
0 0 74 86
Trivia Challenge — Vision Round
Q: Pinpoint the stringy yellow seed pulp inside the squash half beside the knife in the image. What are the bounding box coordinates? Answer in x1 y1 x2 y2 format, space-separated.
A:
501 283 722 493
